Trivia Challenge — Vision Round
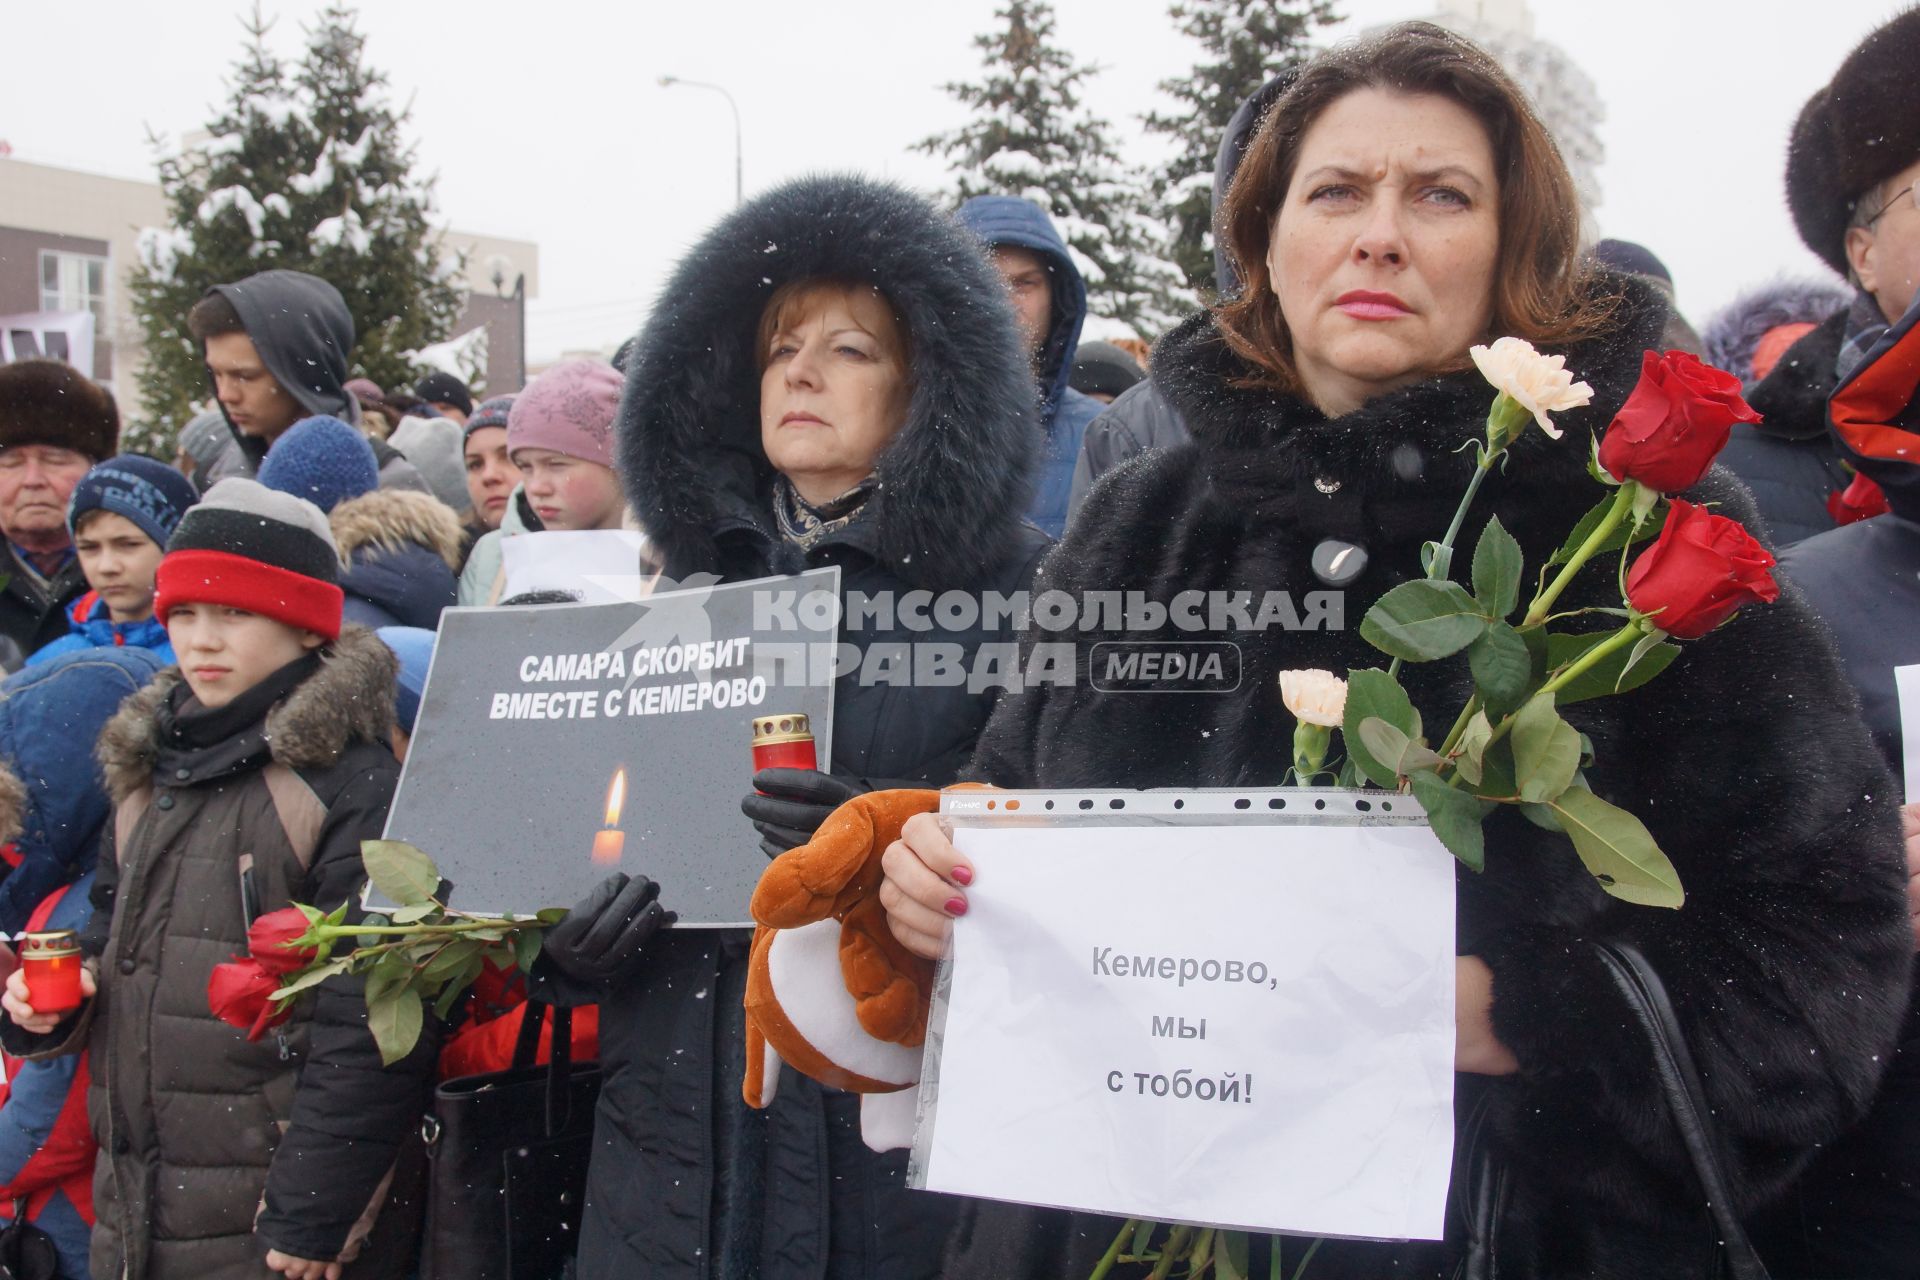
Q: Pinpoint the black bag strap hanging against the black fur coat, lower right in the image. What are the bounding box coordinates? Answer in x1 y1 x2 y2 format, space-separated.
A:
1459 942 1768 1280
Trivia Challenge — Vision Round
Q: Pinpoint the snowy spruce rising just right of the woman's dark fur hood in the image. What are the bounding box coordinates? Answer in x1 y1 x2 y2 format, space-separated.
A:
918 0 1190 340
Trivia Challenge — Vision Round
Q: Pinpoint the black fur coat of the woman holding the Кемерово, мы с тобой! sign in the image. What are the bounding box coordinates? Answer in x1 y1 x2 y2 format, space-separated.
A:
943 284 1912 1280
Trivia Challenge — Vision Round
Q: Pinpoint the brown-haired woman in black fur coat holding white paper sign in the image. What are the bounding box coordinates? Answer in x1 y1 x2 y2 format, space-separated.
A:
881 23 1912 1280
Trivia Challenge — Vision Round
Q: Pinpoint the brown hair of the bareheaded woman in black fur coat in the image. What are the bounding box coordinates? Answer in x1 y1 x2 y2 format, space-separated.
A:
1213 23 1615 391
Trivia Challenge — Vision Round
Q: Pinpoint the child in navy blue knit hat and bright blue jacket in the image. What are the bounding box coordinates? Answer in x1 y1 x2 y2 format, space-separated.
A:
27 453 200 666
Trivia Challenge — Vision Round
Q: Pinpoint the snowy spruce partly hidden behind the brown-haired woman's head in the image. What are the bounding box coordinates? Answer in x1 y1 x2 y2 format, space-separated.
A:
1142 0 1338 297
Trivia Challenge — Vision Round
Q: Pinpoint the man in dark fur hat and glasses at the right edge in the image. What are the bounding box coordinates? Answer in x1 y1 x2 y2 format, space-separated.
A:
1720 8 1920 547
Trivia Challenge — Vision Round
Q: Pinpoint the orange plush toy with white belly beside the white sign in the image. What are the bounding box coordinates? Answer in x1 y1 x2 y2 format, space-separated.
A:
741 791 939 1151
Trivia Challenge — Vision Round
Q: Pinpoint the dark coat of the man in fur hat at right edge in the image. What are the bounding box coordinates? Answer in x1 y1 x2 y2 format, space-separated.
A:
1720 307 1853 549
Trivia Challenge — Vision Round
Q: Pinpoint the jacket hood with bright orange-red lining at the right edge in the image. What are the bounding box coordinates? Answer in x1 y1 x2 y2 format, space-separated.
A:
1828 305 1920 522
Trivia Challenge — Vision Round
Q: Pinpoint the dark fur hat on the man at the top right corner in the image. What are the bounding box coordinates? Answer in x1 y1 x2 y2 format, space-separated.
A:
1788 8 1920 274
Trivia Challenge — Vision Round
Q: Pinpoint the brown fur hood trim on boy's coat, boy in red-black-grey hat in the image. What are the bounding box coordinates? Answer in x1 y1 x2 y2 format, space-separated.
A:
98 626 397 804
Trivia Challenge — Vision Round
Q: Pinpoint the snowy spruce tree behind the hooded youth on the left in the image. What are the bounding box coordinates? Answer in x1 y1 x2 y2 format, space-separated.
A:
131 6 459 447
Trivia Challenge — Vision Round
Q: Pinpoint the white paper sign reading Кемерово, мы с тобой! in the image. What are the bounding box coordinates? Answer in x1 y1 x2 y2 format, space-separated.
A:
914 819 1453 1240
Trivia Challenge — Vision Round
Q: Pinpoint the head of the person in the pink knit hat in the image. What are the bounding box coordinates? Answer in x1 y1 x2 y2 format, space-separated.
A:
507 361 626 530
